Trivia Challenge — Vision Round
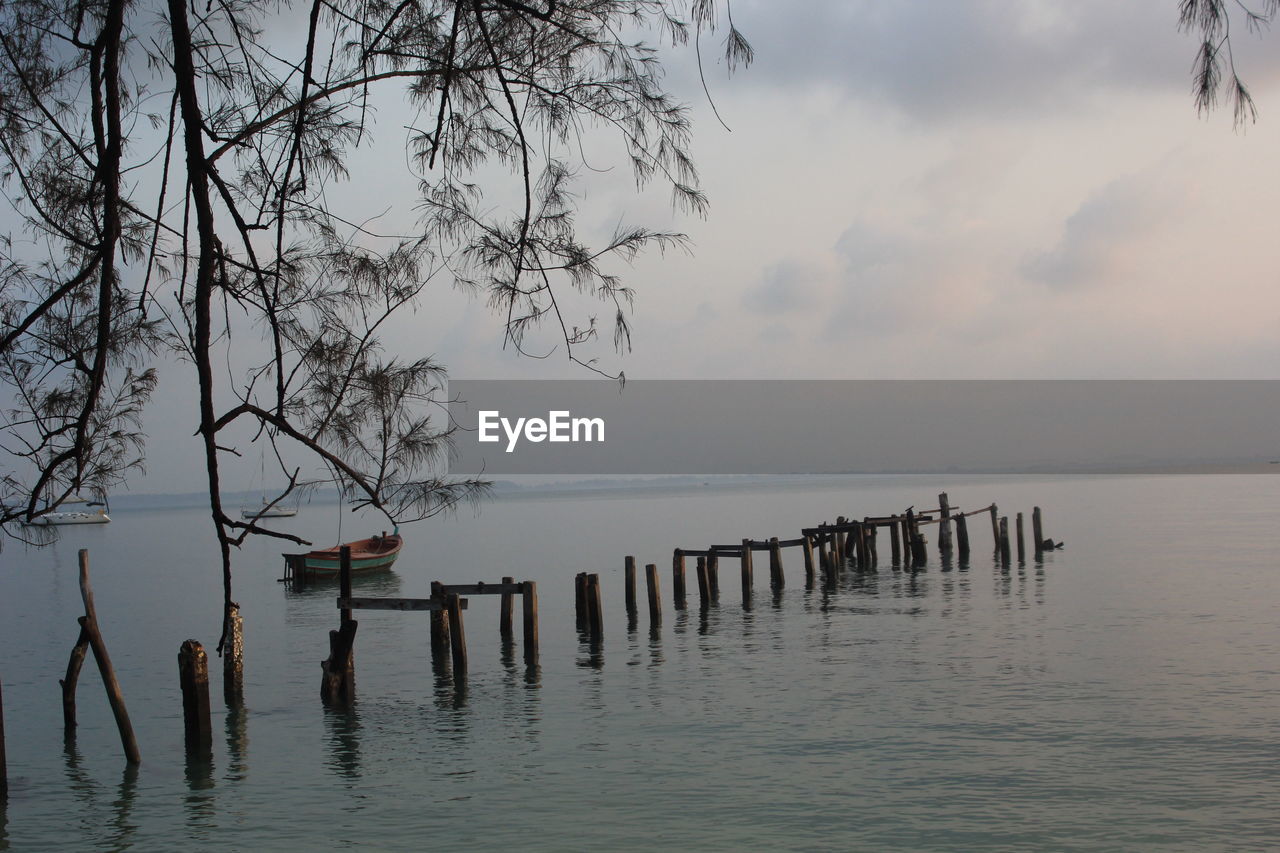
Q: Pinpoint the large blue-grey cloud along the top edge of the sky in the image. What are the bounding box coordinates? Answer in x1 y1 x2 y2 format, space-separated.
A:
735 0 1280 122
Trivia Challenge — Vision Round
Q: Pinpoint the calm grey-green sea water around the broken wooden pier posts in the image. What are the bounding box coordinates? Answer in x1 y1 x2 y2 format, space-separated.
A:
0 475 1280 850
